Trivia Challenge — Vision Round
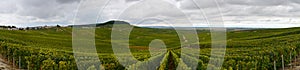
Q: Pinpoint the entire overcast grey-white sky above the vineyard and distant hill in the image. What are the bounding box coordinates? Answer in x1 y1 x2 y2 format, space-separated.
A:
0 0 300 28
